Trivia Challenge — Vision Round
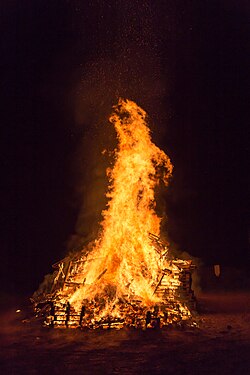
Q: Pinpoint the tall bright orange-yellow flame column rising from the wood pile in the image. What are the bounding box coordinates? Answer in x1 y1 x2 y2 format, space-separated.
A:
68 99 173 307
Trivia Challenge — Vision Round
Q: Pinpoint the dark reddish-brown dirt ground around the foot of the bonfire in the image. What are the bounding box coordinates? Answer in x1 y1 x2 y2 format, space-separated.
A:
0 292 250 375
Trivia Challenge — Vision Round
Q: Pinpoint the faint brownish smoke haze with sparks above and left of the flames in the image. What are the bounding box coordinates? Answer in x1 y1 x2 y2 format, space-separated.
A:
68 1 172 253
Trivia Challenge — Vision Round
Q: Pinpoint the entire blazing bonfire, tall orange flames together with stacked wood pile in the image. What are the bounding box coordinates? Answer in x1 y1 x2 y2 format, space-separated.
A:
33 100 195 329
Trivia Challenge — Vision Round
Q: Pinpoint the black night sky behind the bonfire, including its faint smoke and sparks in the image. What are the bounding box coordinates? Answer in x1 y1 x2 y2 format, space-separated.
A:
0 0 250 293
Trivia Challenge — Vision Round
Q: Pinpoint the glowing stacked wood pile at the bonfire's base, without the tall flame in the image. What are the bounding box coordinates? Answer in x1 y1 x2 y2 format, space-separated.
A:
31 235 198 329
